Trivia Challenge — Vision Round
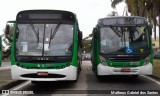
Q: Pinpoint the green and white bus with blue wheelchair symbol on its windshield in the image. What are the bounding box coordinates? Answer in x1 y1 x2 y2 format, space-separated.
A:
91 16 153 78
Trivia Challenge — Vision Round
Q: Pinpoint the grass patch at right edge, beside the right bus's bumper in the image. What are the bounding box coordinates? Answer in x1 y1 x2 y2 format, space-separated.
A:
153 59 160 78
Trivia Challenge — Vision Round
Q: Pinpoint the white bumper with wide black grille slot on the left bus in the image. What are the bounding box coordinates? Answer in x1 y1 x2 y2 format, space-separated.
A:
11 65 77 81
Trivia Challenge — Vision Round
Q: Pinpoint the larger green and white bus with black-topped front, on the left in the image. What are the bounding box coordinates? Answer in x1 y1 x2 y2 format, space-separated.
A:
6 10 82 81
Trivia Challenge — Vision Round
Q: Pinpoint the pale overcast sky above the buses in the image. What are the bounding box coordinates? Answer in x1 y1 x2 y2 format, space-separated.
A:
0 0 125 37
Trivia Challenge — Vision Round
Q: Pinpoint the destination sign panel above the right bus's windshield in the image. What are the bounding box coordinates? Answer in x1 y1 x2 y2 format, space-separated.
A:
98 16 147 26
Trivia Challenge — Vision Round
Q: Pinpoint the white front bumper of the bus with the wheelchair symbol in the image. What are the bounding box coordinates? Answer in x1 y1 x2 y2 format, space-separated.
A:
97 63 152 75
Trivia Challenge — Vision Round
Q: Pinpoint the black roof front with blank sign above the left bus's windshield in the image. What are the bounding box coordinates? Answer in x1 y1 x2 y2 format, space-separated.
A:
16 10 76 21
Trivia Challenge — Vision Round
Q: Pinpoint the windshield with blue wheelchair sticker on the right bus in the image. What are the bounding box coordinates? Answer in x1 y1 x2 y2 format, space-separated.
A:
100 26 149 54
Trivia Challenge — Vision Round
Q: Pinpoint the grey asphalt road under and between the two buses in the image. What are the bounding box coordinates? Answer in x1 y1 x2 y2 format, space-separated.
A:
0 61 160 96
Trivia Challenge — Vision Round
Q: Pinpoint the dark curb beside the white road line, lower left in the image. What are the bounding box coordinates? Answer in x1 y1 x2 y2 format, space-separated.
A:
0 80 25 90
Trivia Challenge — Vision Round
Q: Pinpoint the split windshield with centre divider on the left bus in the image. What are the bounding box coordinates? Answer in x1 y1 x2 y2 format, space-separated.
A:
16 23 73 56
